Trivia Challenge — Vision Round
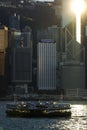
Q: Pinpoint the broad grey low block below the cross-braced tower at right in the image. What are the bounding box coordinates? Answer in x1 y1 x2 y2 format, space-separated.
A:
61 63 85 91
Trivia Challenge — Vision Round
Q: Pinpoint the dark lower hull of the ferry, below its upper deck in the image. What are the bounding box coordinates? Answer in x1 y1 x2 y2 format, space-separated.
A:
6 110 71 118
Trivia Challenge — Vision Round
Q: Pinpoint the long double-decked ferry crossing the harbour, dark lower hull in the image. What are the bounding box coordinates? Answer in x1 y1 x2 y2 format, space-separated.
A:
6 102 71 117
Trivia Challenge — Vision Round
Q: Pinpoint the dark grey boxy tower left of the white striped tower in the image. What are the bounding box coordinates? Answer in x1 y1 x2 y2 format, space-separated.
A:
10 28 32 83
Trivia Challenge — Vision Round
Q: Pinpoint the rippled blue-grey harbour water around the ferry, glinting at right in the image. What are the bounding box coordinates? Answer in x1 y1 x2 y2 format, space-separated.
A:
0 101 87 130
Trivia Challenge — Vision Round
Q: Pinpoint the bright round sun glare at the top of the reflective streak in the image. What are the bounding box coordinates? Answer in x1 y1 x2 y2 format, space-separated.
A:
71 0 85 14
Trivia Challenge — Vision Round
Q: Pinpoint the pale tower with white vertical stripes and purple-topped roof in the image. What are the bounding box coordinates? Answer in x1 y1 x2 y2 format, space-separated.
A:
37 39 56 90
